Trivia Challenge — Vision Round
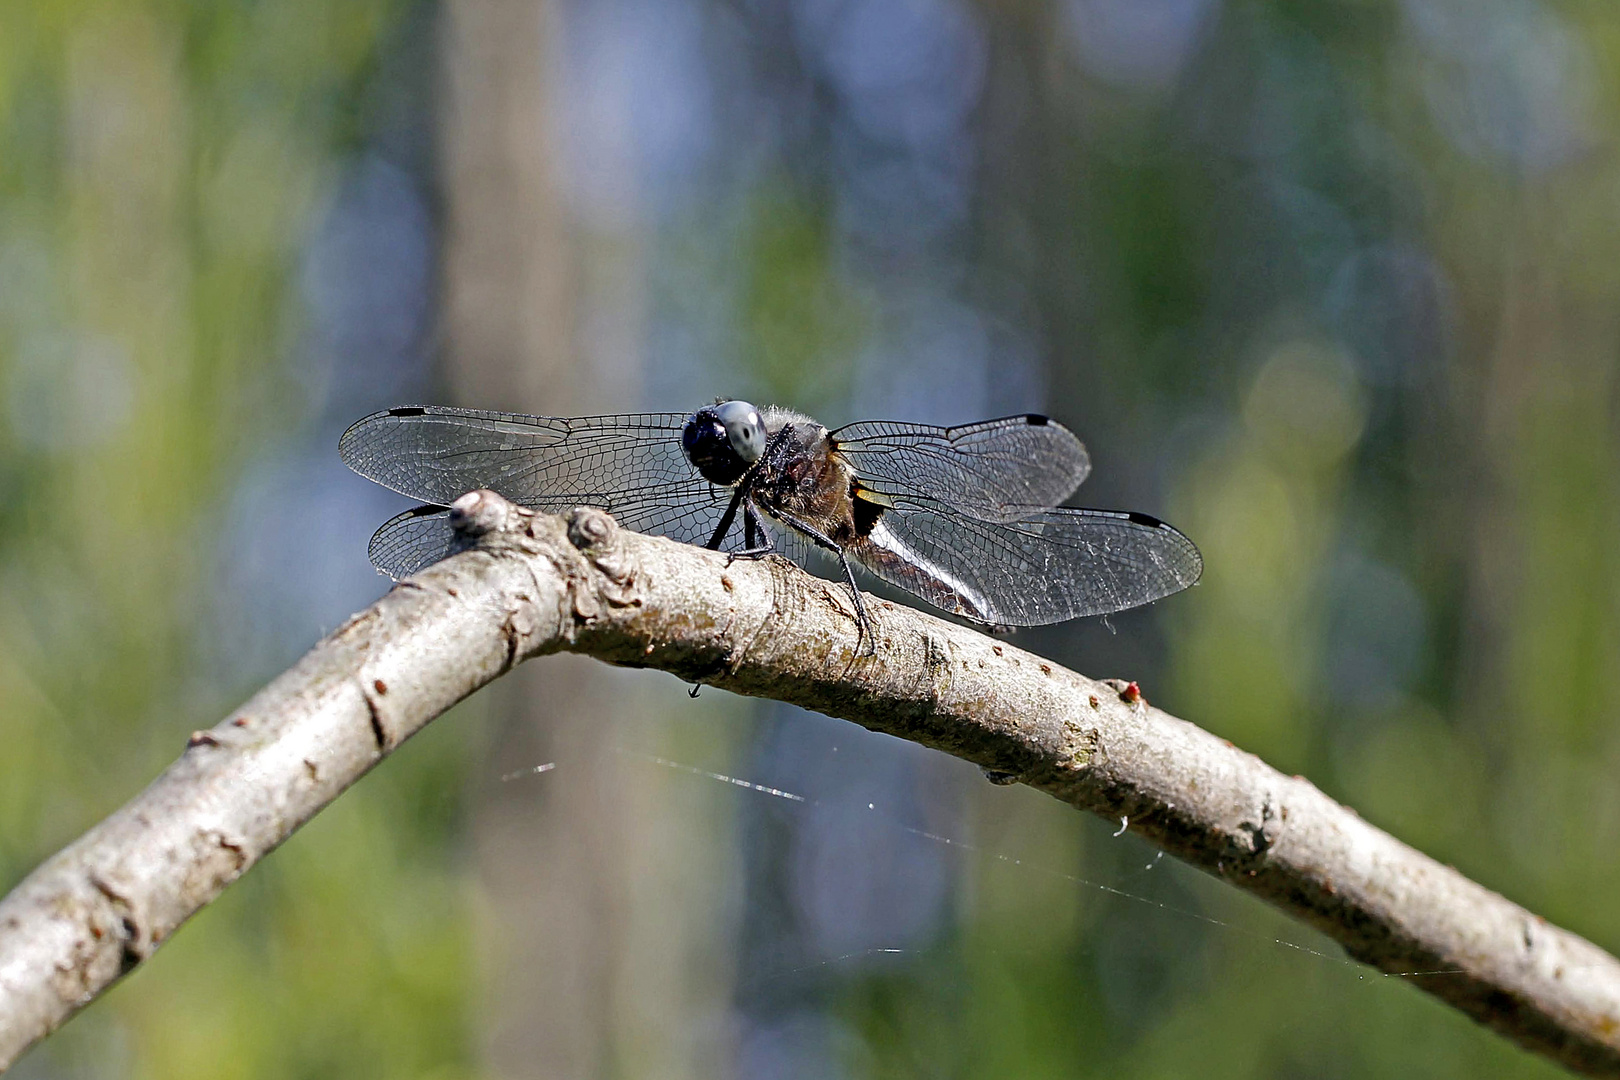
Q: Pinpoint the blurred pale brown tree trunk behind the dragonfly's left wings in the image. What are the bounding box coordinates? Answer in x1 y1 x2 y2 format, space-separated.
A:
439 0 648 1077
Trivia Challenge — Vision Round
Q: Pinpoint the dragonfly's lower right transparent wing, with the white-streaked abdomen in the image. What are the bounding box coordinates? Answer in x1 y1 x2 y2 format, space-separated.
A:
847 497 1204 627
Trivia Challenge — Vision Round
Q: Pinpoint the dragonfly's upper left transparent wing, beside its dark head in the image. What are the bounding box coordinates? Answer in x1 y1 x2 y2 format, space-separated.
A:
337 406 731 557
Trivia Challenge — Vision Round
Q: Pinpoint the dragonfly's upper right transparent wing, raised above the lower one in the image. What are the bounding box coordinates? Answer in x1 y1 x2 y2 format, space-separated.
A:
833 415 1092 521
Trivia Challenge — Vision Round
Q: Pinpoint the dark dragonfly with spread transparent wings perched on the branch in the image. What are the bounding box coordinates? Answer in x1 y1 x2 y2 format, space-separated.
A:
339 398 1204 641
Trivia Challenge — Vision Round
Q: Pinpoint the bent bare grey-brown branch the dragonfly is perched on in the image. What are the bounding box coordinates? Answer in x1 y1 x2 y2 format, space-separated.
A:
0 492 1620 1077
